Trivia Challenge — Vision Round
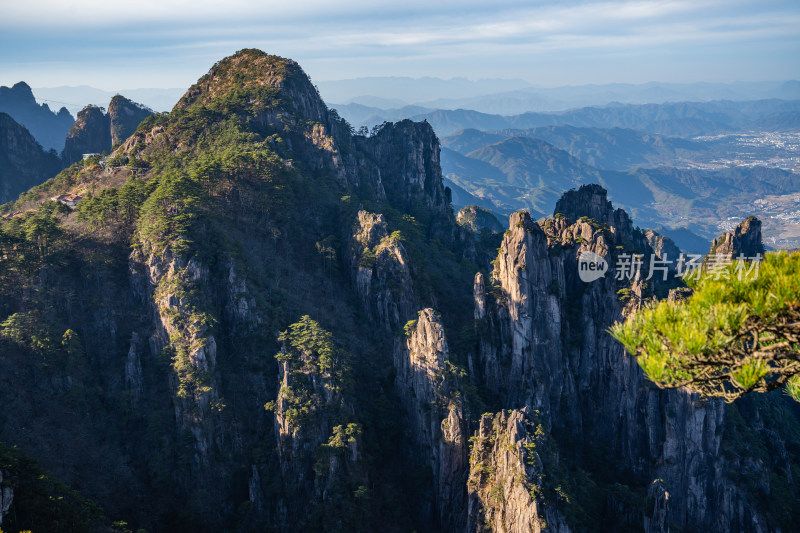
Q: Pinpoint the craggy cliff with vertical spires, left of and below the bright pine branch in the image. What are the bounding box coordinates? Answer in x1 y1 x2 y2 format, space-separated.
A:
475 186 759 531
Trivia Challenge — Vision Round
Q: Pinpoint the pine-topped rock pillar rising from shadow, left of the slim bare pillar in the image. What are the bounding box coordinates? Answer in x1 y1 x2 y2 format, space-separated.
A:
270 317 369 531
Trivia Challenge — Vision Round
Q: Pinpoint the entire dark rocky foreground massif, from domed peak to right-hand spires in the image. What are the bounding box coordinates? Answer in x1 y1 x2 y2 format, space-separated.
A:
0 50 797 532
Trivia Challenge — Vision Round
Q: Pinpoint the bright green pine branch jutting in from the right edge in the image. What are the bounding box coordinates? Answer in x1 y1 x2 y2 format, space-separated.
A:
610 252 800 402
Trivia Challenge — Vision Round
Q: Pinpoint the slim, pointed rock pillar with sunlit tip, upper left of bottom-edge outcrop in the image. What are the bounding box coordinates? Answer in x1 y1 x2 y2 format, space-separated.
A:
394 309 467 531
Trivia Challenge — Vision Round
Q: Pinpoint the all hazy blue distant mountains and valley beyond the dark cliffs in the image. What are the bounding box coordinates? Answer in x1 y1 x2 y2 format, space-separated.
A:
0 77 800 256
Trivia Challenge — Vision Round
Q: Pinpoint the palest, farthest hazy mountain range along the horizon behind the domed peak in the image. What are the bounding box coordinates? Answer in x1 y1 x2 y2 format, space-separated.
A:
18 77 800 121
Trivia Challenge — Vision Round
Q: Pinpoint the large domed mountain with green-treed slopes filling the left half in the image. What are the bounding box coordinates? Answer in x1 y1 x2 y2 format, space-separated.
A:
0 47 478 531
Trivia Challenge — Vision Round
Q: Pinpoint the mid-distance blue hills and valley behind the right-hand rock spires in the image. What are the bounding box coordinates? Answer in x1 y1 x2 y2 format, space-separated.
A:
441 125 800 253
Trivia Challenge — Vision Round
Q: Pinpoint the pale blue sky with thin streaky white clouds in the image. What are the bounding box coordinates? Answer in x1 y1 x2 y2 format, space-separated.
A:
0 0 800 90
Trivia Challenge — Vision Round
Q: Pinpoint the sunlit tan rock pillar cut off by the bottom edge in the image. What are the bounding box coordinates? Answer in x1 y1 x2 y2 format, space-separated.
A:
467 408 570 533
